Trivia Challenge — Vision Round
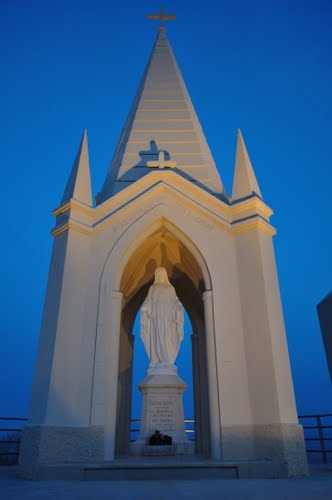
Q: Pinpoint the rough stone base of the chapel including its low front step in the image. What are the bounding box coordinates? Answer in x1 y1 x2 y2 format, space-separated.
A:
17 424 308 480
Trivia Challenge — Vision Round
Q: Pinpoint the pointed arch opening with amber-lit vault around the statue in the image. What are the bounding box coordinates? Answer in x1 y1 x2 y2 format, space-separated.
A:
115 225 210 456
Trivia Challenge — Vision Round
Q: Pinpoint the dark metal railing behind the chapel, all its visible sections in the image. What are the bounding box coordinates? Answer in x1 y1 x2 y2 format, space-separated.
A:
0 413 332 465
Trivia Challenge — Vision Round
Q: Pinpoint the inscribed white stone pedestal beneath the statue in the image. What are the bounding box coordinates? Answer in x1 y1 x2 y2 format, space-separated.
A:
131 373 195 456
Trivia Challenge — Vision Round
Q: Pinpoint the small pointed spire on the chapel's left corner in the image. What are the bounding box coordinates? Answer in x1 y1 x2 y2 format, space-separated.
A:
61 130 92 207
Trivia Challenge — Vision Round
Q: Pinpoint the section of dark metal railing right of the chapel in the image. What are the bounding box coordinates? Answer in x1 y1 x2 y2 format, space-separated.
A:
299 413 332 464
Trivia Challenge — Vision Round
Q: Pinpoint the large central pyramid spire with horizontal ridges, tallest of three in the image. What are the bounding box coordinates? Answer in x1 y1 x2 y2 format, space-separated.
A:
97 28 225 204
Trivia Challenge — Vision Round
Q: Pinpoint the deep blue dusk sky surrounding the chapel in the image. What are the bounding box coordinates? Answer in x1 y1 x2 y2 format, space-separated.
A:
0 0 332 416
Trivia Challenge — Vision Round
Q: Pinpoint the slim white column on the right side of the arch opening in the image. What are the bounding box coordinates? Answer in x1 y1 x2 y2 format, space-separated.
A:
203 290 221 459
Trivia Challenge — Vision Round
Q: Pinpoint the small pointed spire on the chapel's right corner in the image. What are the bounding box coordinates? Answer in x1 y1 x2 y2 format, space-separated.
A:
232 129 262 200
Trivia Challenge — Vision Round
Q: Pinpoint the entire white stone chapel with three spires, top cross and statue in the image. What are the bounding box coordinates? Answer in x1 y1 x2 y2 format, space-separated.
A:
19 6 307 479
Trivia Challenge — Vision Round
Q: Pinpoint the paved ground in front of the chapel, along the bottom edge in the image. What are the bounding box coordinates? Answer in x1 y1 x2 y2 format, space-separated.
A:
0 464 332 500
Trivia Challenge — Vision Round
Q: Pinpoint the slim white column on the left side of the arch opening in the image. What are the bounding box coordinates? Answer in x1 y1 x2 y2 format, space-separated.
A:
104 290 122 460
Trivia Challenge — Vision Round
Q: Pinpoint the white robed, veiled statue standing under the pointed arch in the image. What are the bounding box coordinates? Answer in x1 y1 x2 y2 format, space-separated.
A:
141 267 183 373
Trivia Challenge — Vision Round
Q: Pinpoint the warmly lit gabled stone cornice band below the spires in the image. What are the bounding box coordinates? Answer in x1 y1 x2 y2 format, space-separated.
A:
52 169 275 236
